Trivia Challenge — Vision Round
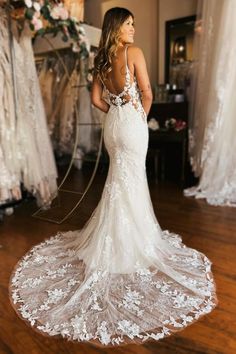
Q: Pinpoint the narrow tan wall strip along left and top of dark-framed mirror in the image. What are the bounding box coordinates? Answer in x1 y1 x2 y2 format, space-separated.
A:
158 0 197 84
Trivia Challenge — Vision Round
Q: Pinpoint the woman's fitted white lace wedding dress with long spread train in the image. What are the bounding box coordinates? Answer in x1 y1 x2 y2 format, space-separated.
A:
10 46 217 345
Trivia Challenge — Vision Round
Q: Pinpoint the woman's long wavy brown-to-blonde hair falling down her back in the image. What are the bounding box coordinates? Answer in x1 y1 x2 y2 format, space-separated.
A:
94 7 134 81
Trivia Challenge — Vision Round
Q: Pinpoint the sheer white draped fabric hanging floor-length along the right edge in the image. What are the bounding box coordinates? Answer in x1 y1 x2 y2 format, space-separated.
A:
184 0 236 206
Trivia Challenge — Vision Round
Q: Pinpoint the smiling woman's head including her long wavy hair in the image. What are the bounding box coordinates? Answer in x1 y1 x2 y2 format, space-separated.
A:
95 7 134 79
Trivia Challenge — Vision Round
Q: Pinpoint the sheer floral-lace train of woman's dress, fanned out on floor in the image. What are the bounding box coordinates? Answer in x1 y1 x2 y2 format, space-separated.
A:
11 231 216 345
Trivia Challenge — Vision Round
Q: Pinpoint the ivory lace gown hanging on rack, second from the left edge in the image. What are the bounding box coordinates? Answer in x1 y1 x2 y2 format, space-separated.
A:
13 23 57 206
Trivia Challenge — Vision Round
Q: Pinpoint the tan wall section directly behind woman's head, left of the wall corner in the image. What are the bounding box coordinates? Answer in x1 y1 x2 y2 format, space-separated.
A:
85 0 158 84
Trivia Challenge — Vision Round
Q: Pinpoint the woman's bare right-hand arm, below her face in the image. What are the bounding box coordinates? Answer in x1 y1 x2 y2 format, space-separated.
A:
128 46 152 114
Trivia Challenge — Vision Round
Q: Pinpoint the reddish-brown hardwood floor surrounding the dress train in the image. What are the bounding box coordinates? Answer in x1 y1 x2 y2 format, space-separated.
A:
0 168 236 354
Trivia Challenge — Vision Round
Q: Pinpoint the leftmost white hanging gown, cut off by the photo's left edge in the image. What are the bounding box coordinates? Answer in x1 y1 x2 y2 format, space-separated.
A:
0 12 21 204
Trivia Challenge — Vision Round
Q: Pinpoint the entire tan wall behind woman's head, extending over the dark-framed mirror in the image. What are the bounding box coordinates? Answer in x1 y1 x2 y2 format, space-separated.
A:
85 0 197 85
